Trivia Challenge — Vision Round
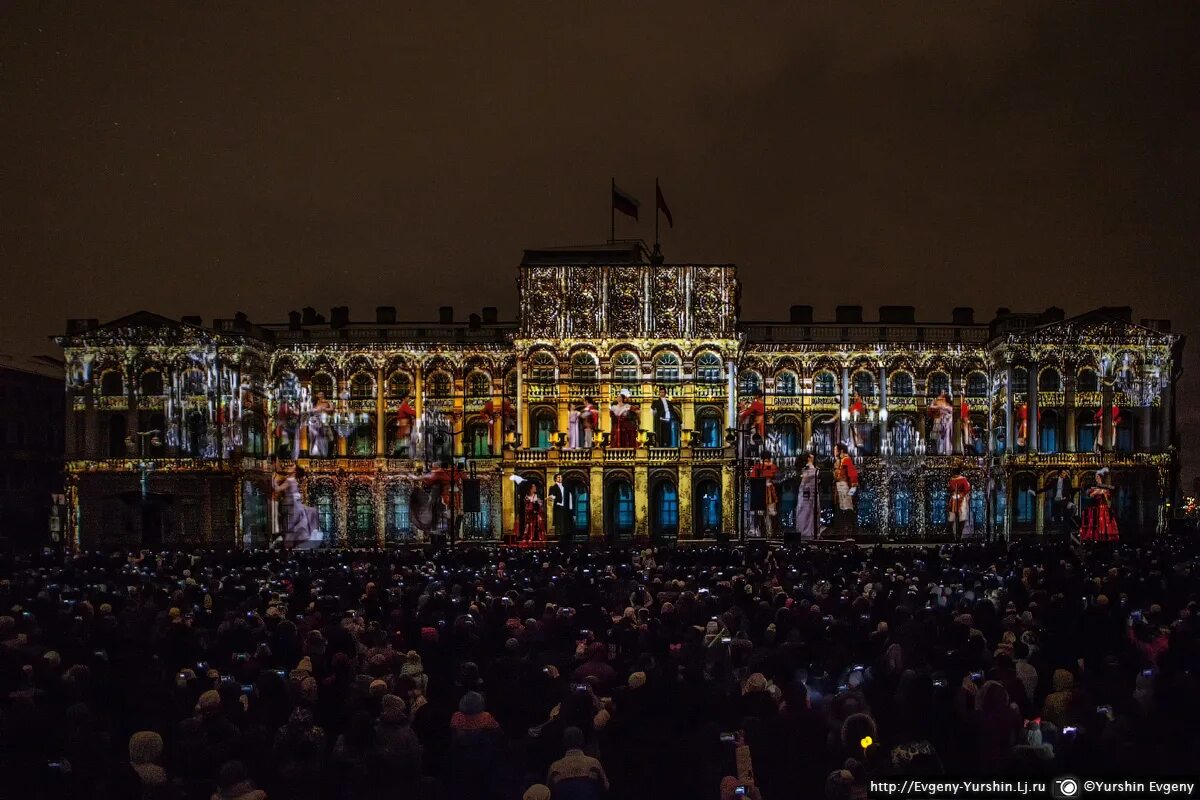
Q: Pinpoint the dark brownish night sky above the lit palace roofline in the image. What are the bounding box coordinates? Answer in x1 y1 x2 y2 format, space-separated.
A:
0 0 1200 475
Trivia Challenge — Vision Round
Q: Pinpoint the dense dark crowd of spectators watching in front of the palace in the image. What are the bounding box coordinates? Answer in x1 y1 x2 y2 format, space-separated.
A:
0 539 1200 800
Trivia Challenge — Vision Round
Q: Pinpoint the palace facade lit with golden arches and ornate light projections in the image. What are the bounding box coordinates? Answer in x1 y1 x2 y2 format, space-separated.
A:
58 243 1182 547
